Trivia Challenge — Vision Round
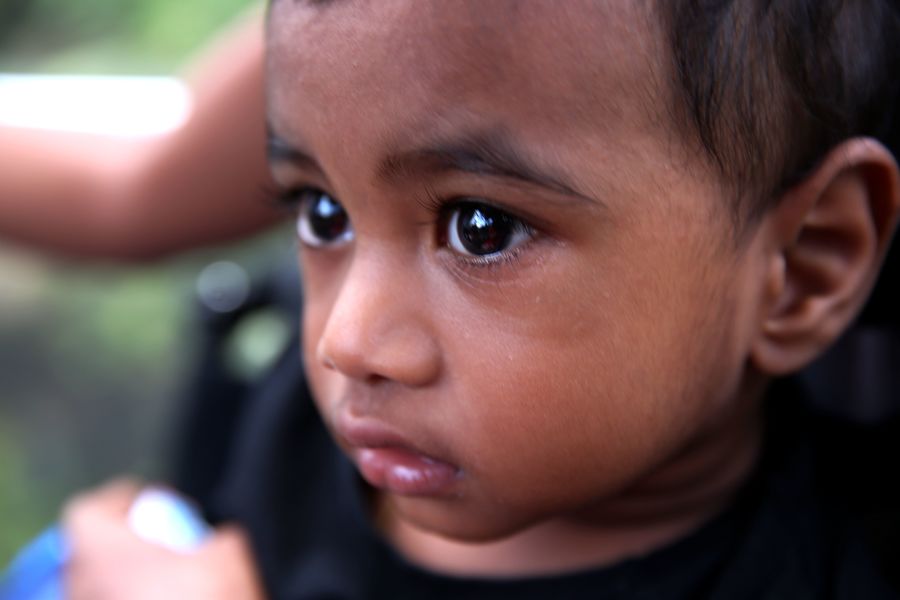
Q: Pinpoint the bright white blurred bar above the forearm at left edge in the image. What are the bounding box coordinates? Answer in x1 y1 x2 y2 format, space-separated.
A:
0 73 191 137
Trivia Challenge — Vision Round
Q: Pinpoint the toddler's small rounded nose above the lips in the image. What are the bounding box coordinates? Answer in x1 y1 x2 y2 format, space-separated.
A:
316 254 441 387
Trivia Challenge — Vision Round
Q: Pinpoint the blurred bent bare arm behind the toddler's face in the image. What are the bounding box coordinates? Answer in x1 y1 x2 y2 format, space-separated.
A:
0 14 277 260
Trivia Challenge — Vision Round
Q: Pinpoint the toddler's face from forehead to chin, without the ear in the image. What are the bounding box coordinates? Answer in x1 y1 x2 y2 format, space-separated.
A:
269 0 759 539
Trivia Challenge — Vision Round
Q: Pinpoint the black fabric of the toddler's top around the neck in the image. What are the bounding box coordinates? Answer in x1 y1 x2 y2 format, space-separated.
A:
172 344 896 600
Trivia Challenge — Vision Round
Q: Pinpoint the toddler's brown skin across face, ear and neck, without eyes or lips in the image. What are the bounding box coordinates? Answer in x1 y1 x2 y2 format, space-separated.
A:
59 0 900 597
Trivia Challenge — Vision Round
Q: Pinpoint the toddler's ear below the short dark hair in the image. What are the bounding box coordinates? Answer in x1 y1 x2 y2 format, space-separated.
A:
751 138 900 375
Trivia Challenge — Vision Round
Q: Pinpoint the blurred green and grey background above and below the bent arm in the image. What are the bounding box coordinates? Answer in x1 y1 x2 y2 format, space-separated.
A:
0 0 291 565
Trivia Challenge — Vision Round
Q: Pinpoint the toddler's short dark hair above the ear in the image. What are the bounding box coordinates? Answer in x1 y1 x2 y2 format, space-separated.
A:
657 0 900 224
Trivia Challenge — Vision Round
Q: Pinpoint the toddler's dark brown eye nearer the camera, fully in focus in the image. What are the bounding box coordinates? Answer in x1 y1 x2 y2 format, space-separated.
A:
447 202 534 257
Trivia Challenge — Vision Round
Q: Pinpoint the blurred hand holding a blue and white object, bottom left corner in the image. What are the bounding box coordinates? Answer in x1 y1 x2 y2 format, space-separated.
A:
63 481 263 600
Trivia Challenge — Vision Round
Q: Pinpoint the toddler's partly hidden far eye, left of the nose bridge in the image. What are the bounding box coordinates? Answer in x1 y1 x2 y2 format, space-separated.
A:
291 188 353 248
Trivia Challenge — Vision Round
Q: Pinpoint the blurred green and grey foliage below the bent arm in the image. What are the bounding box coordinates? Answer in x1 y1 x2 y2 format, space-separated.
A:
0 249 195 562
